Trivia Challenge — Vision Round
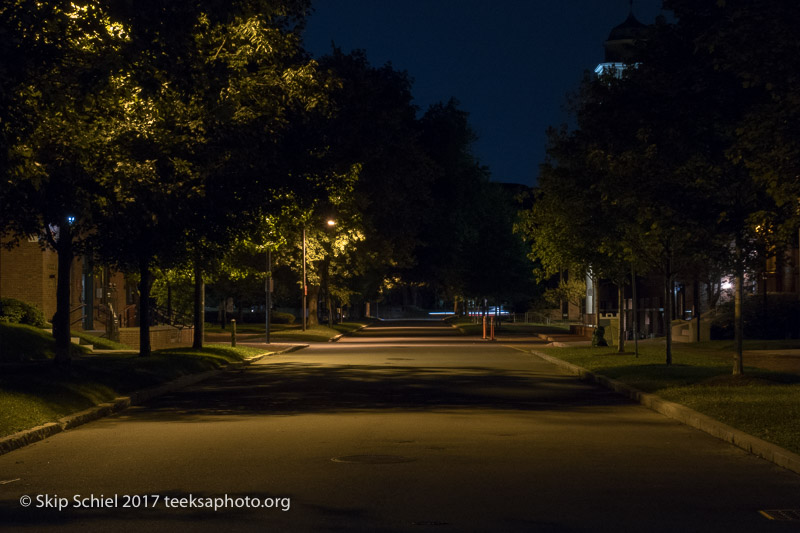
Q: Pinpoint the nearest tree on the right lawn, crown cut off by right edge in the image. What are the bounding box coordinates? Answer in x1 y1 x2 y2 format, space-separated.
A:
665 0 800 373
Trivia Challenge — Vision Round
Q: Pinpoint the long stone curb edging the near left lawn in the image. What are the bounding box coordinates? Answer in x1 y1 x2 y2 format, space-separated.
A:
0 344 308 455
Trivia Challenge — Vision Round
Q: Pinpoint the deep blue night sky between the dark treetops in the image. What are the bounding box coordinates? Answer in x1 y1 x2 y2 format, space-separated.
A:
305 0 661 185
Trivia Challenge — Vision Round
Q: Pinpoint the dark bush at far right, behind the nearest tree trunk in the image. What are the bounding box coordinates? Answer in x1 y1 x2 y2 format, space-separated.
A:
711 294 800 339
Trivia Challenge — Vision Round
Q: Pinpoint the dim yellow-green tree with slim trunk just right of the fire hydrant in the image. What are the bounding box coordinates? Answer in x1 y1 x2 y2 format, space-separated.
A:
520 118 635 352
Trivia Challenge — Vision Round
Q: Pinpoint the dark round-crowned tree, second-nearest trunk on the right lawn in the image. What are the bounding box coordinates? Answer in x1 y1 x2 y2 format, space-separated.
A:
520 16 764 364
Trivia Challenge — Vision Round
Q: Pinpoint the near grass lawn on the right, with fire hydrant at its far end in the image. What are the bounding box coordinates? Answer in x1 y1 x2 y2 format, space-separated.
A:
536 341 800 453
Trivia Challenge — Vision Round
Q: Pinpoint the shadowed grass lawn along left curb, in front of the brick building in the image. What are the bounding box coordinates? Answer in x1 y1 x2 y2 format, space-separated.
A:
0 324 272 437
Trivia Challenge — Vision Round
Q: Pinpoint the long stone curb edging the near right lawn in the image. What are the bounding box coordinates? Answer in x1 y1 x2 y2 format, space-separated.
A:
530 350 800 474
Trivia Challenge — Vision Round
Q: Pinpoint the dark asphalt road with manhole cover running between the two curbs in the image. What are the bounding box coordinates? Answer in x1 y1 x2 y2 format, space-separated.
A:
0 322 800 533
